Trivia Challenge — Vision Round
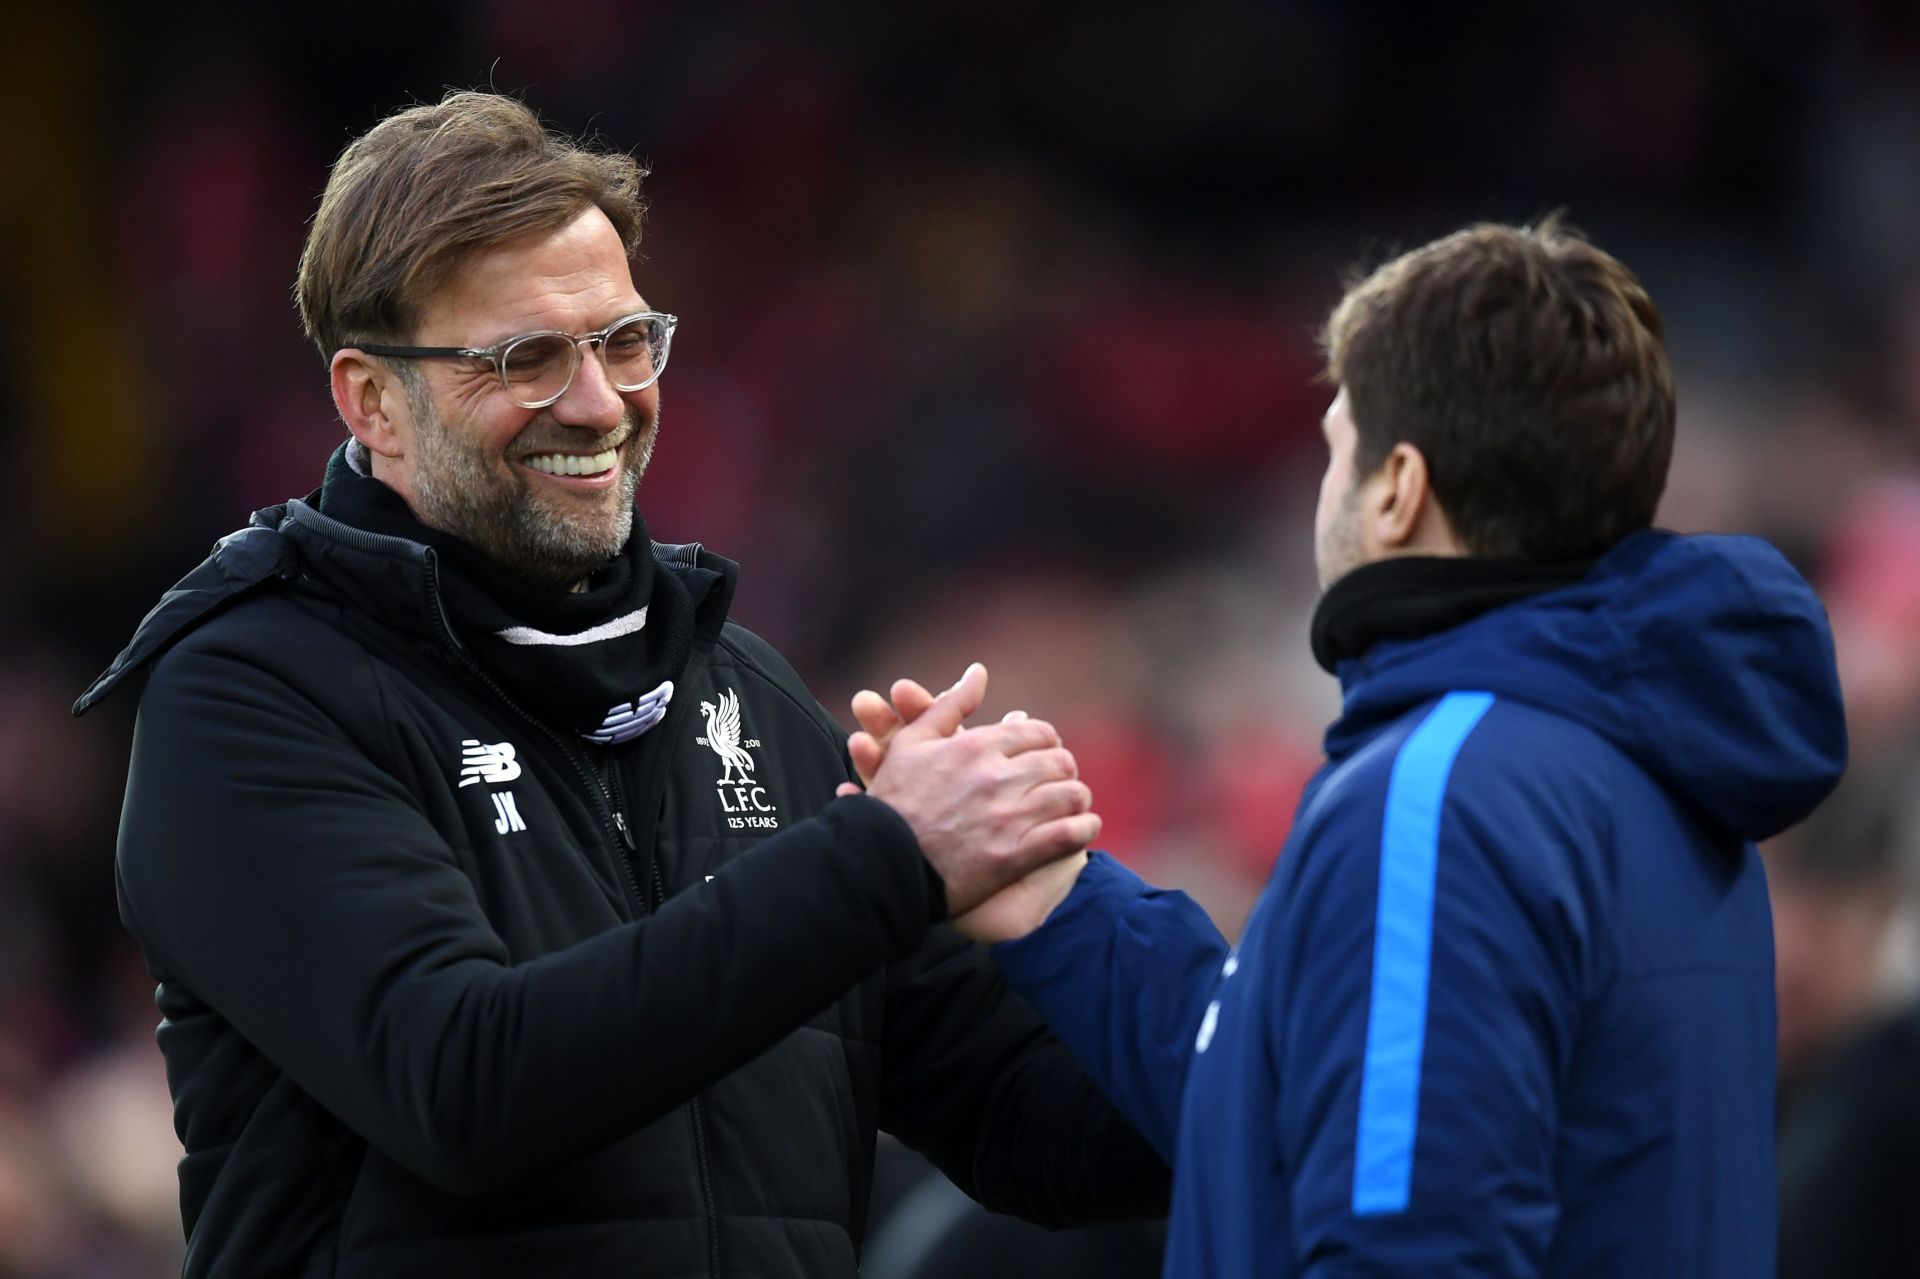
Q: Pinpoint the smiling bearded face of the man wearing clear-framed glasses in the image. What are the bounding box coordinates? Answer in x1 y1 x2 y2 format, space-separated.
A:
374 207 660 586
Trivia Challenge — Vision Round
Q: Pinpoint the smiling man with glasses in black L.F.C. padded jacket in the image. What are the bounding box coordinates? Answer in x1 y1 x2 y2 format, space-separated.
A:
77 94 1167 1275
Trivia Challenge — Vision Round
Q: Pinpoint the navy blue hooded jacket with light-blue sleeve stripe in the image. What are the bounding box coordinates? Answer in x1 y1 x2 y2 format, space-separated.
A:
998 532 1845 1279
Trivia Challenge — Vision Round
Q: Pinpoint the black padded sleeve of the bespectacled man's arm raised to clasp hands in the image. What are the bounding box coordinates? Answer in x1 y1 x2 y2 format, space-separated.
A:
119 645 933 1193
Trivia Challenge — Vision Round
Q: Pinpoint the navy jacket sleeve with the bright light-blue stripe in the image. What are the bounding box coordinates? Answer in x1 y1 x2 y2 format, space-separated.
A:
1263 703 1586 1279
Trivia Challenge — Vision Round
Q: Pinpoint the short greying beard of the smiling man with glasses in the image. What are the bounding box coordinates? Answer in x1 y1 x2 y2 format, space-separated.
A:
407 370 660 590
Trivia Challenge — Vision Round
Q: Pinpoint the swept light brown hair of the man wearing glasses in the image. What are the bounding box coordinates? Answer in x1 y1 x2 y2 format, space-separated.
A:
294 92 647 359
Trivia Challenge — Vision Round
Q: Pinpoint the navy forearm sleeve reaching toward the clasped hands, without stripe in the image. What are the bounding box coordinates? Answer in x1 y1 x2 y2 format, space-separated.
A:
995 853 1227 1162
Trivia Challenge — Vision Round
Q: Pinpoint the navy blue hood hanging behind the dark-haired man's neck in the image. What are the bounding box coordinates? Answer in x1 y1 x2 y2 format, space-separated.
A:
1327 532 1847 839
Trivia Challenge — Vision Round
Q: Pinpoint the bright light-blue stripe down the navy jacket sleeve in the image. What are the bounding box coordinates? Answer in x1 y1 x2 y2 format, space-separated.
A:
1354 693 1494 1216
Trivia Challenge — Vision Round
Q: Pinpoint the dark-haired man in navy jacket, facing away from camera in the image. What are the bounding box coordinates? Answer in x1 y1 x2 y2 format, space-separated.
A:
852 223 1845 1279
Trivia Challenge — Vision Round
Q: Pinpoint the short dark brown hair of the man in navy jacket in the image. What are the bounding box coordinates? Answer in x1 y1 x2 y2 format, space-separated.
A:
1321 217 1674 561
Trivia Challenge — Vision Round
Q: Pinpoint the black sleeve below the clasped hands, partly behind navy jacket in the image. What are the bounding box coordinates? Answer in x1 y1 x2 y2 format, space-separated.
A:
879 902 1171 1227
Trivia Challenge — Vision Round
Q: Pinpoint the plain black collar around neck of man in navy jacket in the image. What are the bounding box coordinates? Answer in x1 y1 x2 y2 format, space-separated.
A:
1311 555 1594 672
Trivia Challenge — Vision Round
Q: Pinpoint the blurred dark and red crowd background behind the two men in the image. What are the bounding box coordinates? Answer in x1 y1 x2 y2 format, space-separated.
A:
0 0 1920 1279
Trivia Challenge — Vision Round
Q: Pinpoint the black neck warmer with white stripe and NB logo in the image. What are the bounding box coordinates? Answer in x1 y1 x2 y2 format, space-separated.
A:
321 444 695 743
